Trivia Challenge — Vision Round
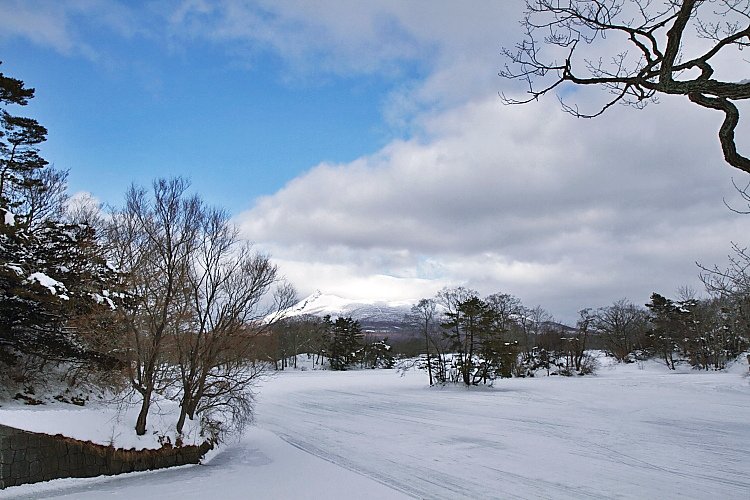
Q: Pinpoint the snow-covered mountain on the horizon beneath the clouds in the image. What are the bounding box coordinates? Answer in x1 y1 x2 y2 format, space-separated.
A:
284 290 417 334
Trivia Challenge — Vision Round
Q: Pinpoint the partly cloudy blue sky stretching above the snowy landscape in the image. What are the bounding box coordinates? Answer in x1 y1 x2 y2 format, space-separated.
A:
0 0 750 322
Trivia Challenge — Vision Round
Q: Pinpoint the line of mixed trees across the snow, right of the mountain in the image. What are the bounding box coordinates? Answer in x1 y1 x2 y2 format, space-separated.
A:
407 282 750 386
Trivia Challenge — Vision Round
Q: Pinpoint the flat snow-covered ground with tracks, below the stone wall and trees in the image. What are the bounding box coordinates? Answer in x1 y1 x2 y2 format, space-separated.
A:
0 365 750 500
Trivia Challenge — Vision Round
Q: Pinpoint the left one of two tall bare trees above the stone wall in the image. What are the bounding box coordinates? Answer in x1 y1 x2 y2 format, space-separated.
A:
107 178 203 435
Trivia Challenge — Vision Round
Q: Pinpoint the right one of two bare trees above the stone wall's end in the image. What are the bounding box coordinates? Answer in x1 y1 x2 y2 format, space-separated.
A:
173 205 295 434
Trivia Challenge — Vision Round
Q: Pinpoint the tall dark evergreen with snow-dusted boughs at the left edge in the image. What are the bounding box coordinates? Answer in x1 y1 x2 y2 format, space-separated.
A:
0 63 116 372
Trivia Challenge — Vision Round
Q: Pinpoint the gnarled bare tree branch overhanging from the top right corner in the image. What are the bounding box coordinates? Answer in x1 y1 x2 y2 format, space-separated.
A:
500 0 750 172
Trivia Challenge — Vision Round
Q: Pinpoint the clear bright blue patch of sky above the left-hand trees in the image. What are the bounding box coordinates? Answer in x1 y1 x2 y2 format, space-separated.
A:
2 18 413 212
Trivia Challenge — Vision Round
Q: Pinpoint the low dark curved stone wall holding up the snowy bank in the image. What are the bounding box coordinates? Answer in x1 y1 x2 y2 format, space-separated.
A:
0 425 212 489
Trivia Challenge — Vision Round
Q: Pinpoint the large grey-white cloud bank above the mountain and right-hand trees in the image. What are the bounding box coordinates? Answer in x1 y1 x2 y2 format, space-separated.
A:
238 92 750 319
